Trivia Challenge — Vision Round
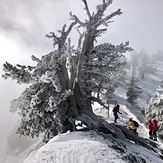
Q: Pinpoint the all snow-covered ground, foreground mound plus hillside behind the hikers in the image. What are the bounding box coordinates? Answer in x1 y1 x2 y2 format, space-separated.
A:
0 63 163 163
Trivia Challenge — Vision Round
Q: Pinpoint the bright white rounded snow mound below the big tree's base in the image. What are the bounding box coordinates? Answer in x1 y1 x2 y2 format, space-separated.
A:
24 131 125 163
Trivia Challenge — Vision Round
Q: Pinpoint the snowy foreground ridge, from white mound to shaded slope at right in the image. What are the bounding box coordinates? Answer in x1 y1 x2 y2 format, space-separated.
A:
23 131 162 163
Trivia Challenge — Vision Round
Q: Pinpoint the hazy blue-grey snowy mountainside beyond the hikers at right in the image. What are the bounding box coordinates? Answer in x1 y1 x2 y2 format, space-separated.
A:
112 61 163 122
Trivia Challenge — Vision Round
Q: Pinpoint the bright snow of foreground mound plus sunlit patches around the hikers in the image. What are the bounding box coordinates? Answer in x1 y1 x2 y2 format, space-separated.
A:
23 104 163 163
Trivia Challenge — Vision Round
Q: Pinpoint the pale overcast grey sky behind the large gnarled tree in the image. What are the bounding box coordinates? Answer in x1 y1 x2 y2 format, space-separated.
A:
0 0 163 143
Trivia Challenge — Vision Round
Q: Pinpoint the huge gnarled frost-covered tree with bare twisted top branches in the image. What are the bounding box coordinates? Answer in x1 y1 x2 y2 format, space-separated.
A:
3 0 132 141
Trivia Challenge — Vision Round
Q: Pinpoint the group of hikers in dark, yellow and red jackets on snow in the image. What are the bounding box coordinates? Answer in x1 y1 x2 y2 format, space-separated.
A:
113 104 157 141
